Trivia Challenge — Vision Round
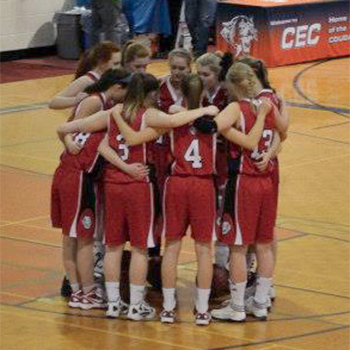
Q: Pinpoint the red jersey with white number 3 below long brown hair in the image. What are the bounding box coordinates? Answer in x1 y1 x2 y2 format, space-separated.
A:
104 108 150 183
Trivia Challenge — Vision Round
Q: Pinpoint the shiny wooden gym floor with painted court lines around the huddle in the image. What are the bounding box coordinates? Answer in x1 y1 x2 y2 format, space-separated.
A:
0 58 350 350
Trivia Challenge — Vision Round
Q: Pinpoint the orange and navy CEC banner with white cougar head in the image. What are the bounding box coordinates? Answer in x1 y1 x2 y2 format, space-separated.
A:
217 0 350 67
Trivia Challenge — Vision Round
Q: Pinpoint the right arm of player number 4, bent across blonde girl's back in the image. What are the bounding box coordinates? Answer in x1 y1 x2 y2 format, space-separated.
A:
221 99 272 150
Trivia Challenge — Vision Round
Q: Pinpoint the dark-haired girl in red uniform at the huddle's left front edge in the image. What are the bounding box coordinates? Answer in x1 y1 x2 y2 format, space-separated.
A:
51 70 130 309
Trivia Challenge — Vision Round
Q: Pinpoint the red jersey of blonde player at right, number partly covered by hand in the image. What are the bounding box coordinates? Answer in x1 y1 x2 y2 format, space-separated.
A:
232 100 275 175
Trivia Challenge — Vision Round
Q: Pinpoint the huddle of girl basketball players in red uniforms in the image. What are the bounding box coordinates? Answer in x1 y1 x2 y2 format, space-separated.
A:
52 40 288 325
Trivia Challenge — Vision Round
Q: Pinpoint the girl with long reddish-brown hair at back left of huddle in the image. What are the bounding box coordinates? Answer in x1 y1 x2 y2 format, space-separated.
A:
49 41 121 109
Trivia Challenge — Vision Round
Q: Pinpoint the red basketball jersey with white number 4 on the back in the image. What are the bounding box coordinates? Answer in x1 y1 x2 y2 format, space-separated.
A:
170 125 216 176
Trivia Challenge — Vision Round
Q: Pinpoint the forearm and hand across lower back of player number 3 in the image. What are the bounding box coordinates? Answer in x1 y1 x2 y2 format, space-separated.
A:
98 135 149 180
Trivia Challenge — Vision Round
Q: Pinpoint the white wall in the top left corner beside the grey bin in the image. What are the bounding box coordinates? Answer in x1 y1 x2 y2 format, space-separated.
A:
0 0 74 52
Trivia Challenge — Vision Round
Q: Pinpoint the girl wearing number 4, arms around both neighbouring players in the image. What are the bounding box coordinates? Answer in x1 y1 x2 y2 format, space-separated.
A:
112 75 266 325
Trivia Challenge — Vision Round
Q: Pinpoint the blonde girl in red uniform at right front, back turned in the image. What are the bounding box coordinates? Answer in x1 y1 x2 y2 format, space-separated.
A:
208 63 279 321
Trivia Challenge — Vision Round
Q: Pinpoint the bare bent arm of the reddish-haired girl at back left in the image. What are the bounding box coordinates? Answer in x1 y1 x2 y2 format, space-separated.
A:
49 76 92 109
